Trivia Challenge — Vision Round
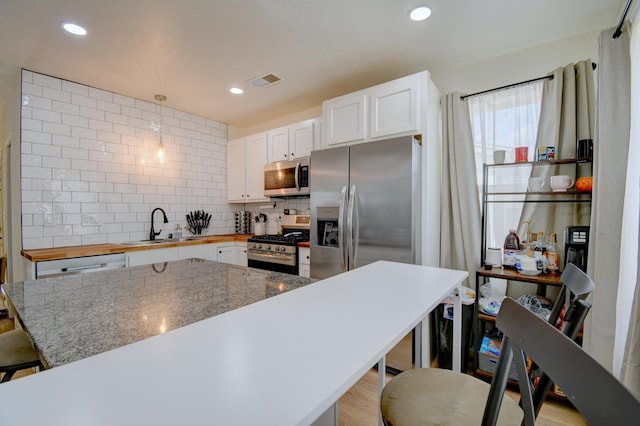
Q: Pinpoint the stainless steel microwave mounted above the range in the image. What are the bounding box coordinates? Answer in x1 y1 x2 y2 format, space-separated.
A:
264 157 310 197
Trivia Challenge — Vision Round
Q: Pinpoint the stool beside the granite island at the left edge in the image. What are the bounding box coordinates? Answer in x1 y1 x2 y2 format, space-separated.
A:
0 330 42 383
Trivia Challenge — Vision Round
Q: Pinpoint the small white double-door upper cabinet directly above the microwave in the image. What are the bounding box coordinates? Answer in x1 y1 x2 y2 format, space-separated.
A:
267 119 316 163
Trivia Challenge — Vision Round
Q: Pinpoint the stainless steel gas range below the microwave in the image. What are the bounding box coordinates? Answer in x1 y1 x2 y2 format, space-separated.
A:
247 215 311 275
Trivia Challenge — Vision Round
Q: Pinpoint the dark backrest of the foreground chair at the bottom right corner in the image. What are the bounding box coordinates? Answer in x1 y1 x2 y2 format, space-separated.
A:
482 298 640 425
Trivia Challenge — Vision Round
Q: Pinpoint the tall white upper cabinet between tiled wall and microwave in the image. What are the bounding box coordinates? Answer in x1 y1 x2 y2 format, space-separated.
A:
227 133 269 203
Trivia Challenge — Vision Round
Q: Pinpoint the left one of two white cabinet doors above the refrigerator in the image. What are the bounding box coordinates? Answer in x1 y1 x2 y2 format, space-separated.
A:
322 92 367 145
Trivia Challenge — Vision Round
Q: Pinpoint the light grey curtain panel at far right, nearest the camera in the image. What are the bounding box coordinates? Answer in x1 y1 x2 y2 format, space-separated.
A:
584 25 638 374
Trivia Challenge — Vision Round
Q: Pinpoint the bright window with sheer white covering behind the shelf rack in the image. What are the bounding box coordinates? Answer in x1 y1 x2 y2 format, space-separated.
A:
469 81 543 250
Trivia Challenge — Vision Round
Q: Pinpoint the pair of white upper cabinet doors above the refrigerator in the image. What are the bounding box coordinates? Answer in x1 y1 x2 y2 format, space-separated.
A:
316 71 429 149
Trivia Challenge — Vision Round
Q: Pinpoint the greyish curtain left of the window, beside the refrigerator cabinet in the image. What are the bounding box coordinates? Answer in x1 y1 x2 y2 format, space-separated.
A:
440 93 480 288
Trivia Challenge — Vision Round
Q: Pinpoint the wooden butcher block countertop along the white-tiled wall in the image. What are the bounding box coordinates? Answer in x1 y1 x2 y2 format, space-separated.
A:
21 234 252 262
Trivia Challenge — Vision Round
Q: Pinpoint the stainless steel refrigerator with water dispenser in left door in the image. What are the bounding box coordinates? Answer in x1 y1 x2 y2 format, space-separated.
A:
310 136 422 370
